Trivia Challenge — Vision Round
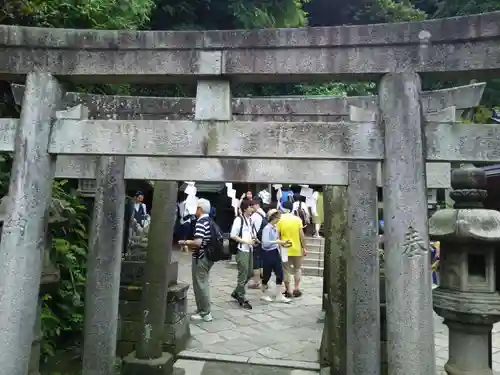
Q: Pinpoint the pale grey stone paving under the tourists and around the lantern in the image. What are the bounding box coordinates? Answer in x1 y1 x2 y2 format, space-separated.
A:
174 248 500 375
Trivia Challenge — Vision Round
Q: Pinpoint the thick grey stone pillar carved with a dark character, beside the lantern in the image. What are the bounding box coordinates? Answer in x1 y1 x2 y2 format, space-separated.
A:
379 72 436 375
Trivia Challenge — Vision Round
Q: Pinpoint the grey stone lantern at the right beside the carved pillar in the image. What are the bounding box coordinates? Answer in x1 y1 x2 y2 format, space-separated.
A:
429 166 500 375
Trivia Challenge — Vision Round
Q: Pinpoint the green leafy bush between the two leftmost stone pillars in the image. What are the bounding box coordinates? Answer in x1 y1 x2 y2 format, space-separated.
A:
42 180 89 355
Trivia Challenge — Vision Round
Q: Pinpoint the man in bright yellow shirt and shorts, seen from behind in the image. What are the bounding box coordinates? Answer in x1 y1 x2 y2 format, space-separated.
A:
277 201 307 298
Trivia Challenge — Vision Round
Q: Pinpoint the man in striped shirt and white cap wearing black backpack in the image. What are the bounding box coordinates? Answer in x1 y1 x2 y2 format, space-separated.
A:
179 199 231 322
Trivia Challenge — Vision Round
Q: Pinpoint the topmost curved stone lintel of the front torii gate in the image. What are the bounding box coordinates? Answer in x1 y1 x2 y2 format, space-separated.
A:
0 12 500 83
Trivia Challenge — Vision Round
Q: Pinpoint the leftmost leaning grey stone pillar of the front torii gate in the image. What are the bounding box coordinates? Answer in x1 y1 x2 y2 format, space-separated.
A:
0 72 63 375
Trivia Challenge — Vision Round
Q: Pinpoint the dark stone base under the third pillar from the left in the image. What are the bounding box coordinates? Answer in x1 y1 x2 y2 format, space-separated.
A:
121 352 175 375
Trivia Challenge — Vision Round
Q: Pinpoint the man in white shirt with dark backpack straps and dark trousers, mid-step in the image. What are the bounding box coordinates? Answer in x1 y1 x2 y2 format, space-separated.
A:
231 199 257 309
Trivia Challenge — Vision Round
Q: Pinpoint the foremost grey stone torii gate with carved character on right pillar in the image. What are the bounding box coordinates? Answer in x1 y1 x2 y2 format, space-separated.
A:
0 13 500 375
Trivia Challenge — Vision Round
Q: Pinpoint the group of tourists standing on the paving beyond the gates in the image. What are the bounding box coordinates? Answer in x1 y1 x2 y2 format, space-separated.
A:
175 192 311 322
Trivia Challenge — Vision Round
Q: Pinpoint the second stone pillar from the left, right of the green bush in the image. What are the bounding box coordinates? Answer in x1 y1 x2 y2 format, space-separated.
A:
82 156 125 375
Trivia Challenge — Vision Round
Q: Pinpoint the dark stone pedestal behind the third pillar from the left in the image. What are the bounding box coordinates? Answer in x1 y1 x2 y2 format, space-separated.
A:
117 256 191 357
